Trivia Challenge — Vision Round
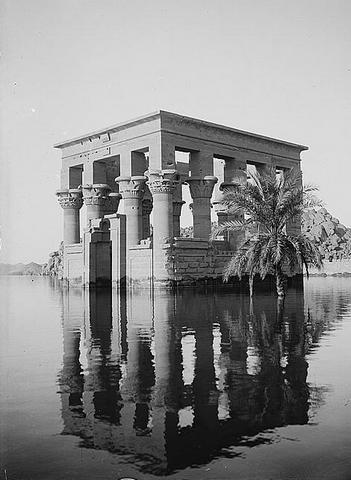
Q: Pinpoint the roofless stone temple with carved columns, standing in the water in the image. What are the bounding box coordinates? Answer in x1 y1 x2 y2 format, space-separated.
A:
55 111 307 287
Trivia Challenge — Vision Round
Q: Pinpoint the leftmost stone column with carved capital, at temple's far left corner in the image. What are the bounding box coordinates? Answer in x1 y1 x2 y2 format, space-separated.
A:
56 188 83 245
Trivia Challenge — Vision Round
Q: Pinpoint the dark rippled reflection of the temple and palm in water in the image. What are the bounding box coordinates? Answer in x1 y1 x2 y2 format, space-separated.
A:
59 289 334 475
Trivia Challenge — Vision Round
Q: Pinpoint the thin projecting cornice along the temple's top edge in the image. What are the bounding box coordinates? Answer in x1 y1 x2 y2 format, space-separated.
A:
54 110 308 150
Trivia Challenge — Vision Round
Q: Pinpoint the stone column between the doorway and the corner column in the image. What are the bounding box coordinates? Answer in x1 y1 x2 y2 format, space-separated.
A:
116 176 146 249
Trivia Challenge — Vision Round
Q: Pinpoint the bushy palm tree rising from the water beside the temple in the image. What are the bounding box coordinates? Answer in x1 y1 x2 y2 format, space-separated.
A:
212 167 322 298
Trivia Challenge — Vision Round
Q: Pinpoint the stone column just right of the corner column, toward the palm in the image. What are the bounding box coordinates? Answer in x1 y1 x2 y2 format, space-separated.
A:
186 175 218 240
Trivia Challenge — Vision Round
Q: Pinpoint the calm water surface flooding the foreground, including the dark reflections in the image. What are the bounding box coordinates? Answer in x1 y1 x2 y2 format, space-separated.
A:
0 277 351 480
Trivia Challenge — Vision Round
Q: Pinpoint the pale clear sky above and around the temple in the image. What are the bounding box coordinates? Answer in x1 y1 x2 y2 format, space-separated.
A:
0 0 351 263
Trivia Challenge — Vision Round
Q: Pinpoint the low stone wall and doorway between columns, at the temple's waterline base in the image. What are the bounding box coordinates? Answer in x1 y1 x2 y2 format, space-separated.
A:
63 218 302 289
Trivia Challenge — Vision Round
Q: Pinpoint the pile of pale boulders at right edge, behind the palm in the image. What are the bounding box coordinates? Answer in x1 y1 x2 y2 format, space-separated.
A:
302 208 351 261
